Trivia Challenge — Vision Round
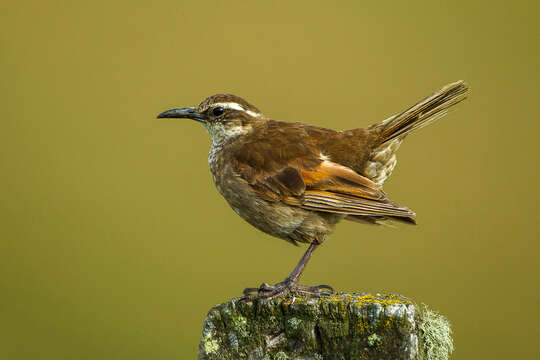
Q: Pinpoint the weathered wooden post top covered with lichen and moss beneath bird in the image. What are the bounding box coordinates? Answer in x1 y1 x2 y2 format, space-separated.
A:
199 294 453 360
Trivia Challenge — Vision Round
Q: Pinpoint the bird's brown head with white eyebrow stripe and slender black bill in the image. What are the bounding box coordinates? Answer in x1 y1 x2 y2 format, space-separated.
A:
157 94 265 144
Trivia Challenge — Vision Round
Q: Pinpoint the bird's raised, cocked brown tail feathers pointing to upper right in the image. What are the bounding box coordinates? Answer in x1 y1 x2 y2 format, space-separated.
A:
378 80 469 145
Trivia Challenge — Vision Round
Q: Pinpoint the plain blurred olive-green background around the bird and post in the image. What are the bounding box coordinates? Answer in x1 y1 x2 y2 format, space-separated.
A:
0 0 540 360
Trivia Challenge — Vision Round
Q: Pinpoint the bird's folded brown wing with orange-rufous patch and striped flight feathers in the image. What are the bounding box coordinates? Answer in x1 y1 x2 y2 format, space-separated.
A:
233 124 415 218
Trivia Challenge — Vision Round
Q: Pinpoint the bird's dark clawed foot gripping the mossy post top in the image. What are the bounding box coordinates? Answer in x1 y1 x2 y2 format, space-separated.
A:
242 279 334 300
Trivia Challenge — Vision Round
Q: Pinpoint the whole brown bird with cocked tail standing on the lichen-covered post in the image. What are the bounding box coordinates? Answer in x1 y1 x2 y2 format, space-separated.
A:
157 80 469 300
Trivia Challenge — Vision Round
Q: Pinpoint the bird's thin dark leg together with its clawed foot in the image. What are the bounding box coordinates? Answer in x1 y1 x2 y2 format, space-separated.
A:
244 243 334 300
